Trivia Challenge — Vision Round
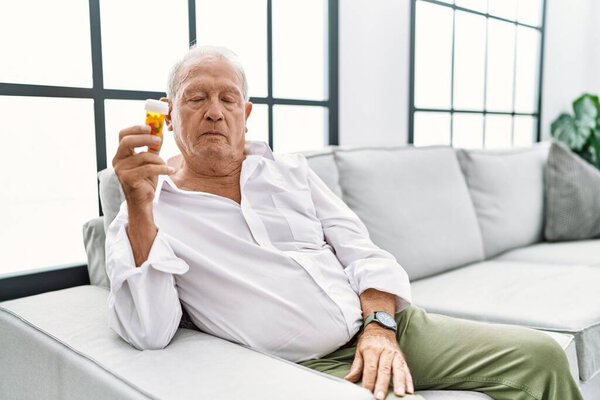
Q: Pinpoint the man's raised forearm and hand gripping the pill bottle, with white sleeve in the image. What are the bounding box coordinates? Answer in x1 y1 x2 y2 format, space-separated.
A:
106 122 189 349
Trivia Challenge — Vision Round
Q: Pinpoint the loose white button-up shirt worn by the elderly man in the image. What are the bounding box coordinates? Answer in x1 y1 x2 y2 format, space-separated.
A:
106 142 411 362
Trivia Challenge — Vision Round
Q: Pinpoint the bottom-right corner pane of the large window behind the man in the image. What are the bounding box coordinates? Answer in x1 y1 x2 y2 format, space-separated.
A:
273 105 328 153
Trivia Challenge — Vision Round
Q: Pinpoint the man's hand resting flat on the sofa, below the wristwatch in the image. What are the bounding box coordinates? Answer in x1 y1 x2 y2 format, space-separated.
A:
344 323 415 400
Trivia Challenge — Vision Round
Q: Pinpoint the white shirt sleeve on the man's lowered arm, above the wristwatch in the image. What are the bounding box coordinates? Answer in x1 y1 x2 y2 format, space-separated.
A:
308 168 412 312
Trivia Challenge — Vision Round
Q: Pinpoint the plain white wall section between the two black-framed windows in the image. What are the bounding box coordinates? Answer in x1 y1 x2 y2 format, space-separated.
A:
339 0 411 147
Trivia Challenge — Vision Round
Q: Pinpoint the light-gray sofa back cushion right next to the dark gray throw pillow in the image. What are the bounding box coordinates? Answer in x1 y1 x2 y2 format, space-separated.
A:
456 143 549 258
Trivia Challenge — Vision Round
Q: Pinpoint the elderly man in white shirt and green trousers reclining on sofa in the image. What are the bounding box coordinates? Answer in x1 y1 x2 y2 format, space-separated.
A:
106 47 581 400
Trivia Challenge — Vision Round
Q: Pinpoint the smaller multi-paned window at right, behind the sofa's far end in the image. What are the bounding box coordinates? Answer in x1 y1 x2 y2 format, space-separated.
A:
409 0 545 148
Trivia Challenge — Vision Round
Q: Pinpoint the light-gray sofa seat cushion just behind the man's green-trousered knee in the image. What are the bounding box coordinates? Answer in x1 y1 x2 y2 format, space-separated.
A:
412 261 600 381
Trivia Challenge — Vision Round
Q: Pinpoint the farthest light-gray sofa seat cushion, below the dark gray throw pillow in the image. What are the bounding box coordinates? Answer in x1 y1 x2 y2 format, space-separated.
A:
495 239 600 267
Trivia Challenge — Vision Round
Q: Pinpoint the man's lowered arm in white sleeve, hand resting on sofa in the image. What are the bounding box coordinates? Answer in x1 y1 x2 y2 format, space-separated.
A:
308 169 414 399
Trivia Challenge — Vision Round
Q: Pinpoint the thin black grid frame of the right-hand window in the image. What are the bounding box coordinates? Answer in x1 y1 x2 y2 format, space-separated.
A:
408 0 547 148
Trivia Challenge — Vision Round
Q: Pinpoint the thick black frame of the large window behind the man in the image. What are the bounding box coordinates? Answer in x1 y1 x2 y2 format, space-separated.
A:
0 0 339 301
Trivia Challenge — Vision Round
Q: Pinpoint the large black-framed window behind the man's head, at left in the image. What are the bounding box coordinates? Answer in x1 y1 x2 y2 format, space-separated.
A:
0 0 338 277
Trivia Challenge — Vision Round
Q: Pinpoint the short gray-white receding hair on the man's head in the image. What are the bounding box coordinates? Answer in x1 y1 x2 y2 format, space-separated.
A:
167 45 248 101
